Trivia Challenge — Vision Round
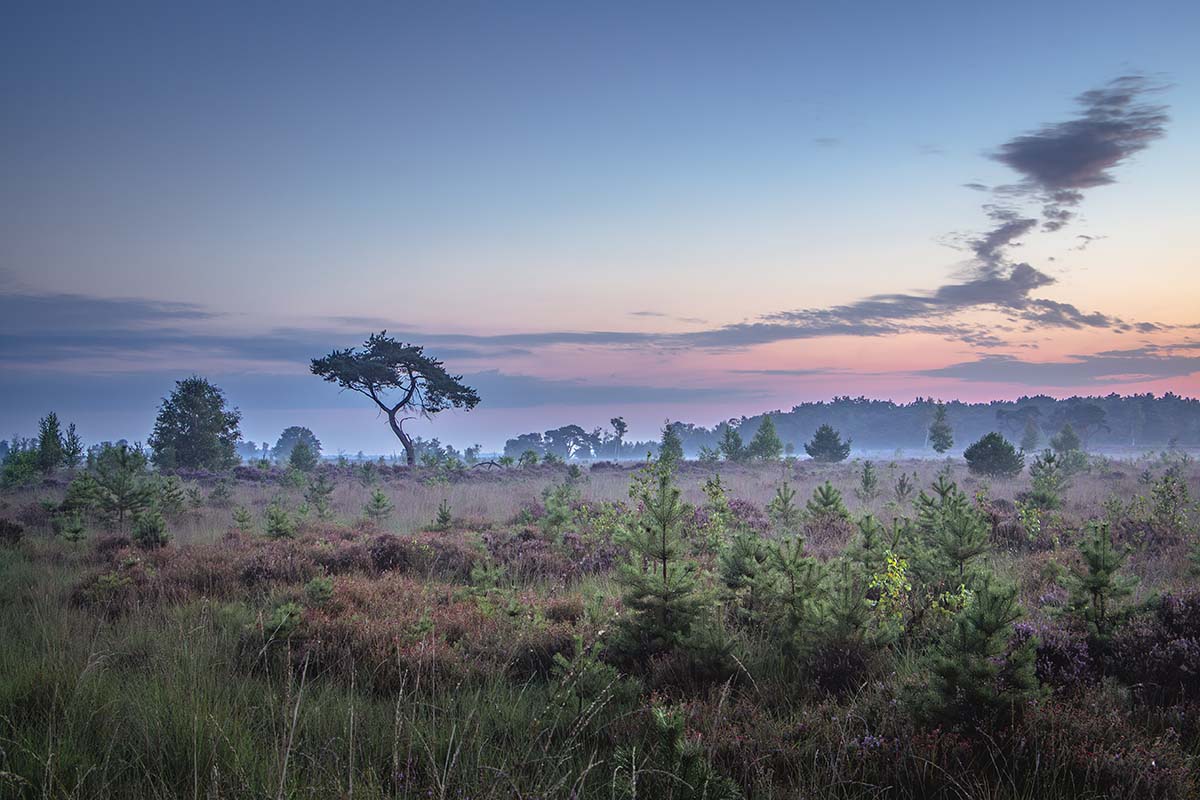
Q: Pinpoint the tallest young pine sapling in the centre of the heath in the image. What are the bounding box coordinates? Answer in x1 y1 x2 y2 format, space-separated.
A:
617 462 704 660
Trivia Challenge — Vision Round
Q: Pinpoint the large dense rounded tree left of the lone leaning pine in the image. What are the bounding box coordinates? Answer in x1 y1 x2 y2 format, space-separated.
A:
149 375 241 470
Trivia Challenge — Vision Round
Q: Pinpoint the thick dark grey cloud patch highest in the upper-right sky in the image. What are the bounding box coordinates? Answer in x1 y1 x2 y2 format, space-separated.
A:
992 76 1168 230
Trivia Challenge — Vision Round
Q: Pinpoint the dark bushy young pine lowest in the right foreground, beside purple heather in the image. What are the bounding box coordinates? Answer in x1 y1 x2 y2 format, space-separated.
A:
916 579 1039 730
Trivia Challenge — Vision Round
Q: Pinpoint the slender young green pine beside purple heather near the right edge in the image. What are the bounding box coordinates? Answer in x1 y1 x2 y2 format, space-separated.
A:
1067 521 1138 654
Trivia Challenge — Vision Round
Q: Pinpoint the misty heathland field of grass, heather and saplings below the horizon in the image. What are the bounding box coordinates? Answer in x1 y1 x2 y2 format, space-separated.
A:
0 455 1200 800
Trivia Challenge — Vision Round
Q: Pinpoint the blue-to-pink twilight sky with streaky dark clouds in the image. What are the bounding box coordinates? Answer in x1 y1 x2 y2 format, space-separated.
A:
0 1 1200 452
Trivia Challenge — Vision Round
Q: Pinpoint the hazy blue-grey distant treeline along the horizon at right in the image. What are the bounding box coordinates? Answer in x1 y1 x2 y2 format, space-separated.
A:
504 392 1200 459
